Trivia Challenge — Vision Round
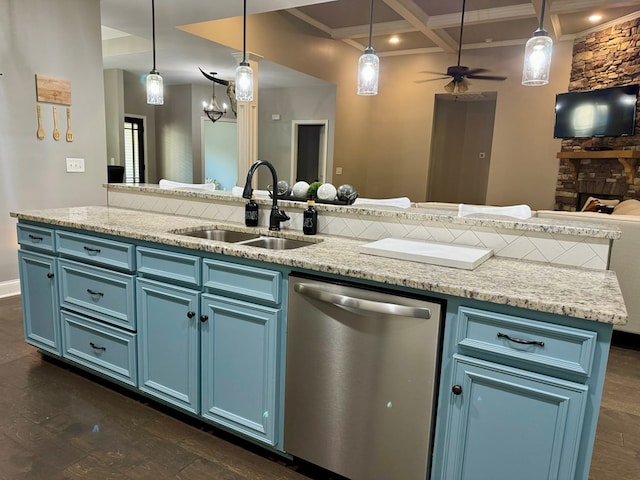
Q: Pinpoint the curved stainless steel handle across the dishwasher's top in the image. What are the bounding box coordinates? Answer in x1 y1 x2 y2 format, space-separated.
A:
293 283 431 319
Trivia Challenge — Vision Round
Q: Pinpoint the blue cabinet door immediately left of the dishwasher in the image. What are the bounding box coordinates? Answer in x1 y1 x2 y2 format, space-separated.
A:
200 294 280 445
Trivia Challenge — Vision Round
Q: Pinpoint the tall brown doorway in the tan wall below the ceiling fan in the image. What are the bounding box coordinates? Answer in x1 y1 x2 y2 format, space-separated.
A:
427 92 497 205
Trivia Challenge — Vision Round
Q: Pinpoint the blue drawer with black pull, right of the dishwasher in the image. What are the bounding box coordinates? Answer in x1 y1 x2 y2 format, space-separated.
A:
457 307 597 376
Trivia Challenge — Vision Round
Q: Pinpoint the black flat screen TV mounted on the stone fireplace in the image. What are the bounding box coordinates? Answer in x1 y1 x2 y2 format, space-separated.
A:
553 85 638 138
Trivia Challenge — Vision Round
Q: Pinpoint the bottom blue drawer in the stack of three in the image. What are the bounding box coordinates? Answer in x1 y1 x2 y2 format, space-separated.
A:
62 310 138 387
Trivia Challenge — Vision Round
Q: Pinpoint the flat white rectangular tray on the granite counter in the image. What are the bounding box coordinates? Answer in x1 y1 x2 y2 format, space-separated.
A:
360 238 493 270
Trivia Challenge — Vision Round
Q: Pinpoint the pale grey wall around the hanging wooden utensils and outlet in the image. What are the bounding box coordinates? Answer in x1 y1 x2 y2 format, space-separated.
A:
0 0 107 283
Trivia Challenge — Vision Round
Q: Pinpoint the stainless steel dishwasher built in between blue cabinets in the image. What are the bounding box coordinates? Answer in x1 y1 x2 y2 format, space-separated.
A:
284 275 444 480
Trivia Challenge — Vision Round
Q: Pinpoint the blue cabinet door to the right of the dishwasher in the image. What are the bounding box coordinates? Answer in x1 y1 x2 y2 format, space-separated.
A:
434 354 588 480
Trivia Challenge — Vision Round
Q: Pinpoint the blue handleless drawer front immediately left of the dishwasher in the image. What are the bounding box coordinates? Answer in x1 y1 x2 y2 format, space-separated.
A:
202 259 282 305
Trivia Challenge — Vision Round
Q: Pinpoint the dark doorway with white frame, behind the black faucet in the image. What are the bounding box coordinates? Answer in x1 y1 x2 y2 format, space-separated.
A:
291 120 329 184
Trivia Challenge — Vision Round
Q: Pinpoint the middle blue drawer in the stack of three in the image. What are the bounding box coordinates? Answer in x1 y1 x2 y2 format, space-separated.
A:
58 259 136 330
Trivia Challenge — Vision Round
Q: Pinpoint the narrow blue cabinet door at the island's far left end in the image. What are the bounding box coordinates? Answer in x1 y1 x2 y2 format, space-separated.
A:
18 250 62 355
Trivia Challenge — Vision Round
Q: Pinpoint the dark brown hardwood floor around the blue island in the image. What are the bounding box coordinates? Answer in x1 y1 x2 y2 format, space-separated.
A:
0 296 640 480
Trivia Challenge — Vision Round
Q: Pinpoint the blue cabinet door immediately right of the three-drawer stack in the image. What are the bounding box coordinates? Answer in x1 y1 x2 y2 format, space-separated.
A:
136 278 200 413
